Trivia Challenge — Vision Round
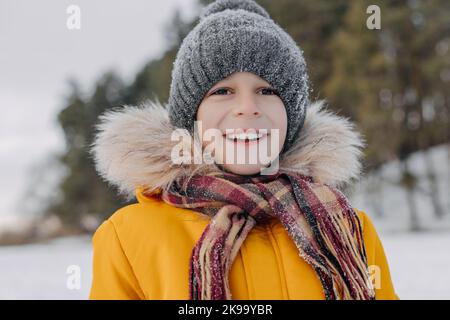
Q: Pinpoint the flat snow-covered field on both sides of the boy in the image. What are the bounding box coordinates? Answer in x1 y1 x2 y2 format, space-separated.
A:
0 232 450 299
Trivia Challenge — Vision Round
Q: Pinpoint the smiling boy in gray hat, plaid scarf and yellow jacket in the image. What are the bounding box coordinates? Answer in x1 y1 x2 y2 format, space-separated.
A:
90 0 398 300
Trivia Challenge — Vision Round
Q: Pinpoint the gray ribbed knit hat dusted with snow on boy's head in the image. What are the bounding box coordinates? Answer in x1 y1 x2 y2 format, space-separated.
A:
168 0 309 152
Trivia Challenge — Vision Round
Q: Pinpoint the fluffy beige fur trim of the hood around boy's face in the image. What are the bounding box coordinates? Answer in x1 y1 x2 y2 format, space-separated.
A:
90 100 365 200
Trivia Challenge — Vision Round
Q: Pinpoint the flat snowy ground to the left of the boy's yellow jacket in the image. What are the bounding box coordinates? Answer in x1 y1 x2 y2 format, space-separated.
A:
0 236 92 300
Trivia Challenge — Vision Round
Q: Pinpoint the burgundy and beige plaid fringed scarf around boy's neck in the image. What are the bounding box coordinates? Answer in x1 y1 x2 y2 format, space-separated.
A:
162 171 375 300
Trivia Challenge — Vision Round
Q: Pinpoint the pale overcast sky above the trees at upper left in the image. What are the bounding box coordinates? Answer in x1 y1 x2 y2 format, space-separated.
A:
0 0 198 229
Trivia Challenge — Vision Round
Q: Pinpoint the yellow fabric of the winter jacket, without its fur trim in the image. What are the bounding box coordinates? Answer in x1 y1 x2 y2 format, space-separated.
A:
89 189 397 300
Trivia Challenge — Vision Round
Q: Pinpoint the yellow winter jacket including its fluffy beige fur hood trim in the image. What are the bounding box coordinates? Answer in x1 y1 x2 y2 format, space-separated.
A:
89 102 398 299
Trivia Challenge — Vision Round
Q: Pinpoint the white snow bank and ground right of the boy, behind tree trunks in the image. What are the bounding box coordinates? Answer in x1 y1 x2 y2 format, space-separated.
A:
350 144 450 299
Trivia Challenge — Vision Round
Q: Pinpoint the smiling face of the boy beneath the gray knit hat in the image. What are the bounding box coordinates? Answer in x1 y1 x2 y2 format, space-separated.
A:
197 72 287 175
